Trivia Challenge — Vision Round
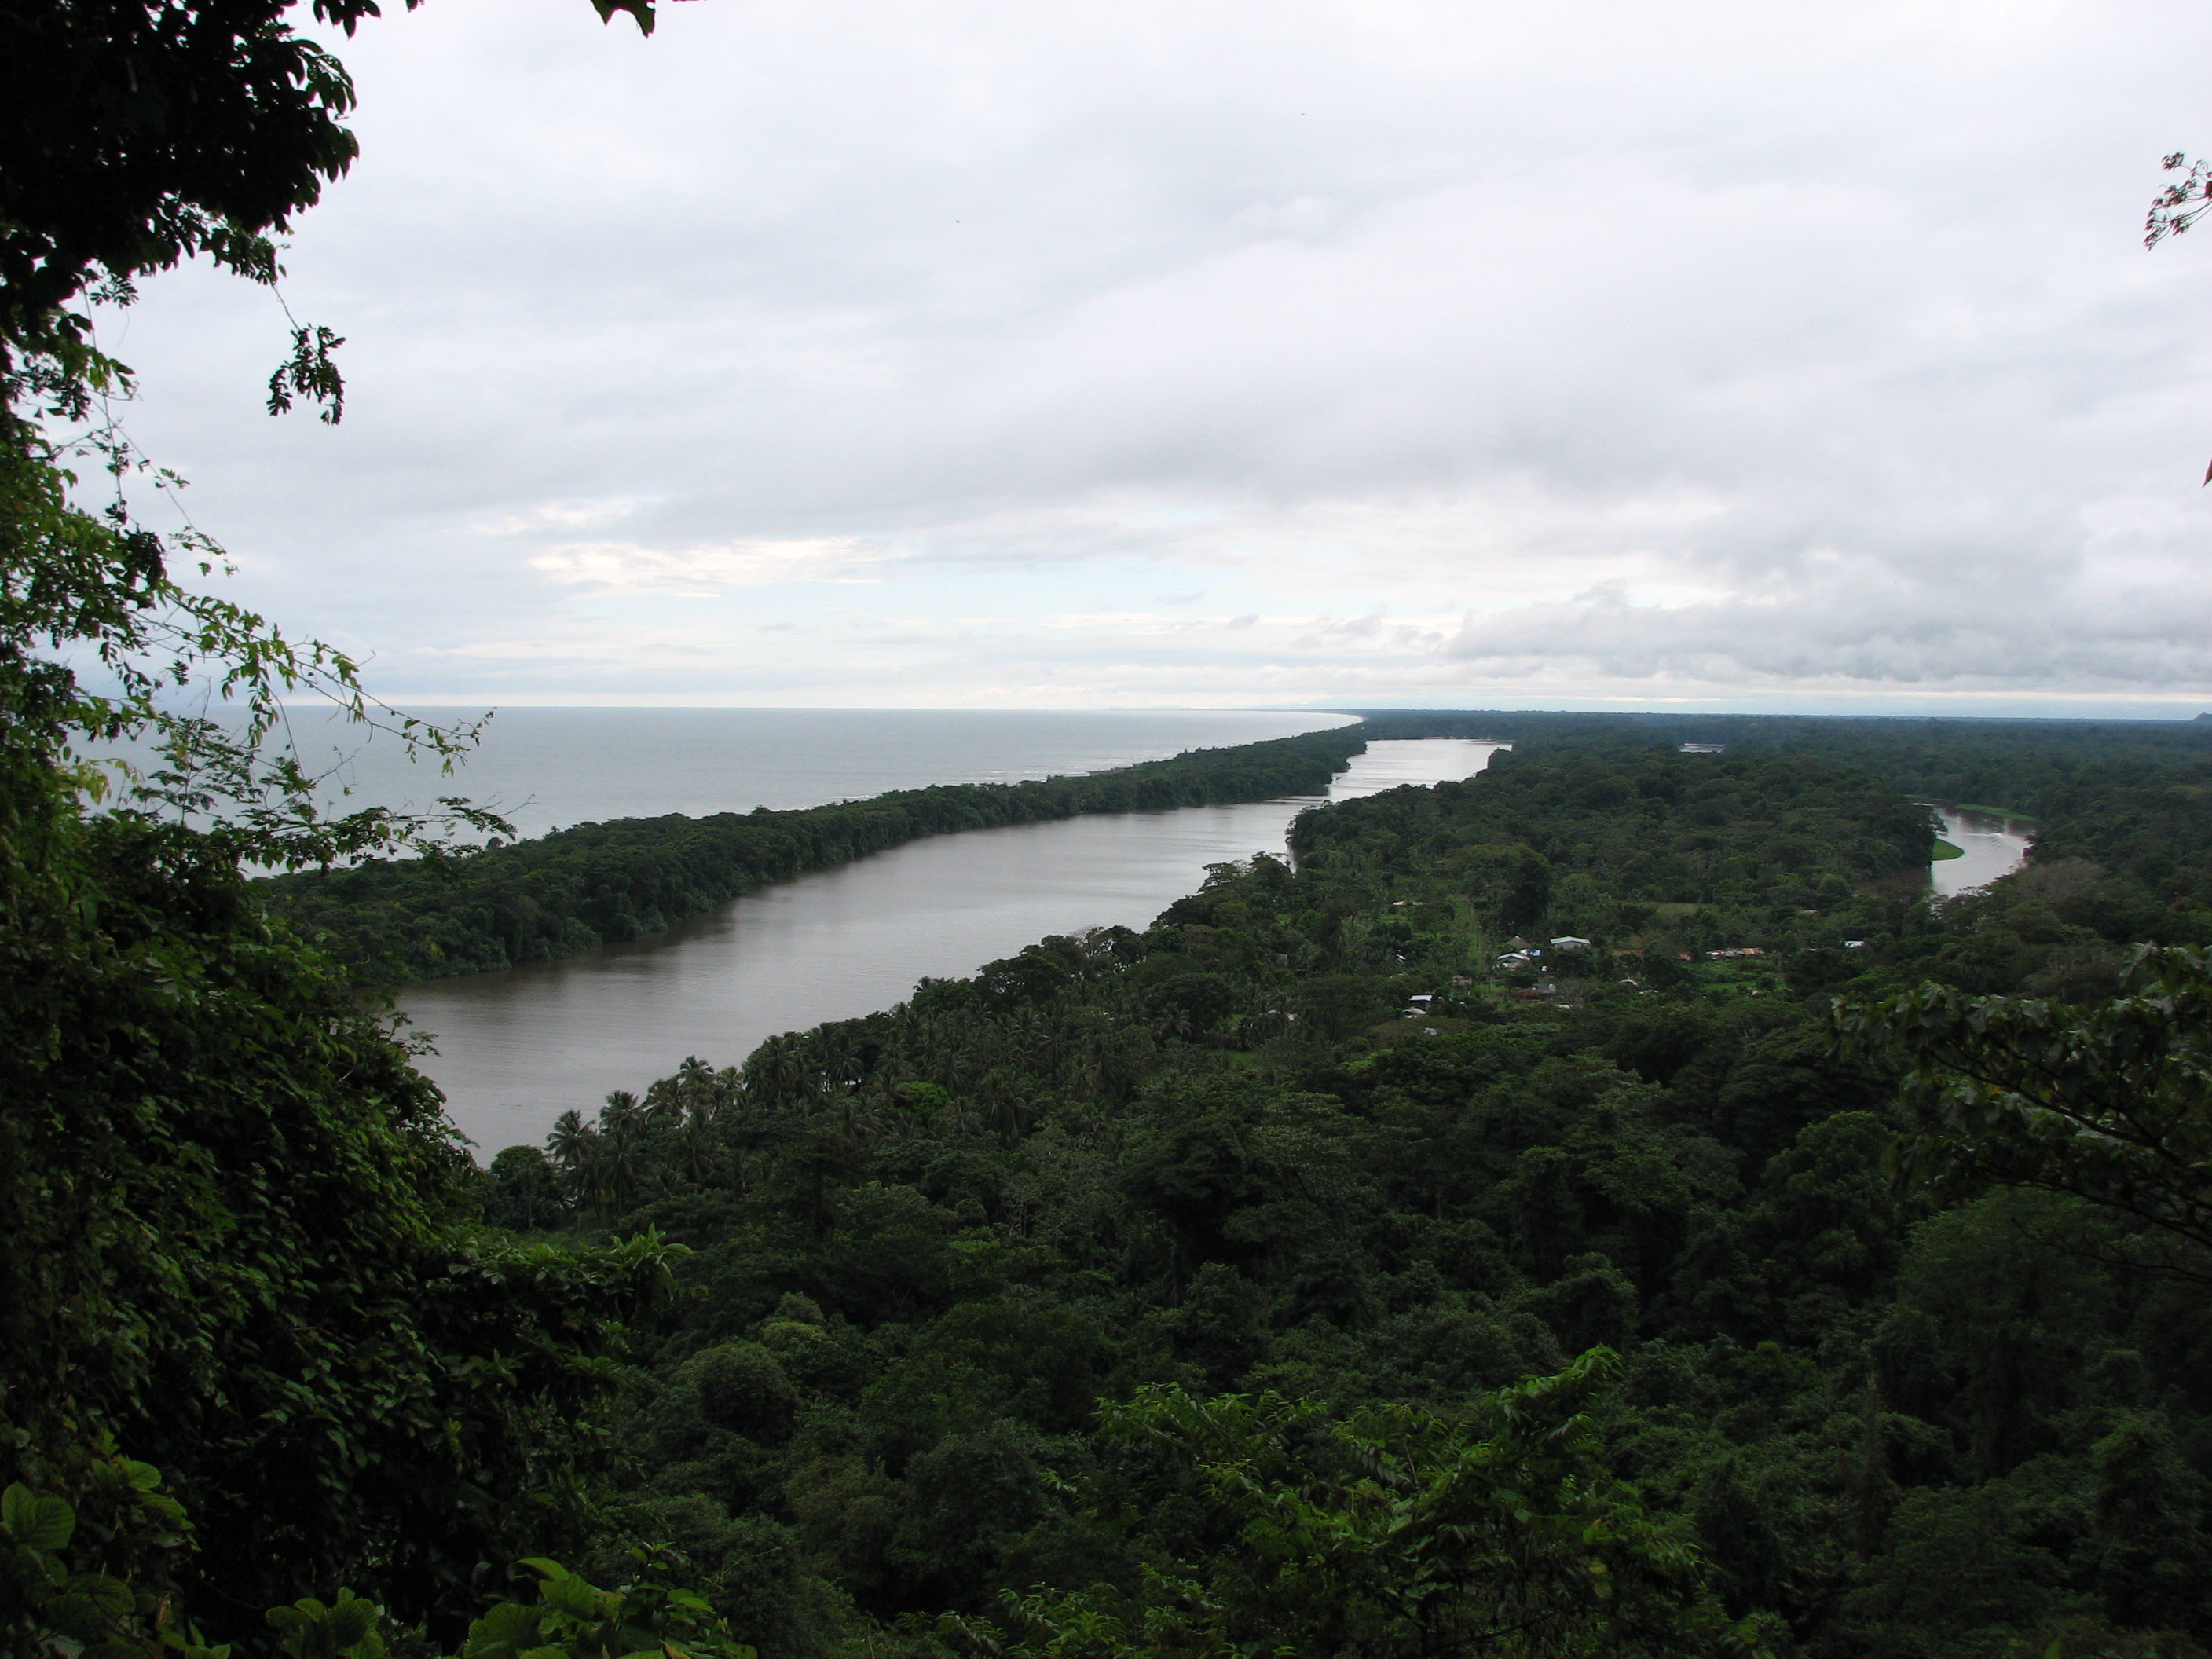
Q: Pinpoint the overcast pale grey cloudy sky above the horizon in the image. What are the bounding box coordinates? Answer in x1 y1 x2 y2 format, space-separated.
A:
104 0 2212 715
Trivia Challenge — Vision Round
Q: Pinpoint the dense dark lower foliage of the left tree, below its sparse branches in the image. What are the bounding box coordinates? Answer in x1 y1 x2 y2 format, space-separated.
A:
0 708 690 1617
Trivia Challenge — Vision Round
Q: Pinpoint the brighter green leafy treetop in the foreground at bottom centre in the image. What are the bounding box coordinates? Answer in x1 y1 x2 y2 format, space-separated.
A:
986 1350 1752 1659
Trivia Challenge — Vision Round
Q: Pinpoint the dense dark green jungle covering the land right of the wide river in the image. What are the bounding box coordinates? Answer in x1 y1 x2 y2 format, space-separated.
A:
453 737 2212 1659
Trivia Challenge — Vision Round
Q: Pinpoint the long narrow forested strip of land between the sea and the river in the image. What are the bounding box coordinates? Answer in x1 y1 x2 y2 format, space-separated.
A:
268 727 1364 980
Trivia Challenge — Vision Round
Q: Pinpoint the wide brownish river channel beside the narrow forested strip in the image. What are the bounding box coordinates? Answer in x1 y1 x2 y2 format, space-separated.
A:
401 739 1500 1155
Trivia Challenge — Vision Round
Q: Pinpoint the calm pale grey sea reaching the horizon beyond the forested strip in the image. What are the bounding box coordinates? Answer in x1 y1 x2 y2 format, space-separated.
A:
253 708 1352 836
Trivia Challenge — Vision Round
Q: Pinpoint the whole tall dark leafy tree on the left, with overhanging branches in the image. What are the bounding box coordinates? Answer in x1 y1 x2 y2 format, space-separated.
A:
0 0 698 1646
